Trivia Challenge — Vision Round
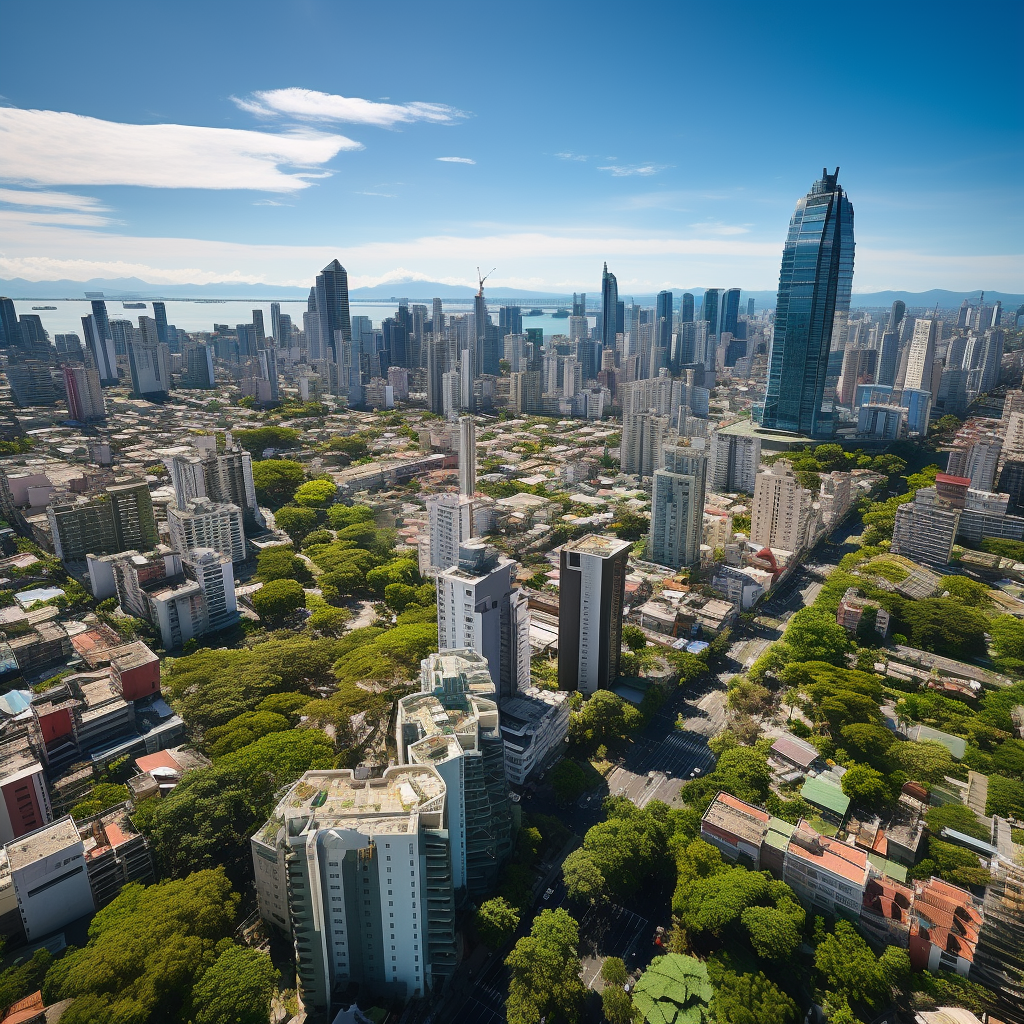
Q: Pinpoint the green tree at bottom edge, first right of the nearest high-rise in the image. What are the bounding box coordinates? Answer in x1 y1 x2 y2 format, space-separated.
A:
505 908 587 1024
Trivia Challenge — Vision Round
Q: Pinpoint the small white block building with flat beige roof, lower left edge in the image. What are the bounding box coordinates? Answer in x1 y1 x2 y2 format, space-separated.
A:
4 815 95 942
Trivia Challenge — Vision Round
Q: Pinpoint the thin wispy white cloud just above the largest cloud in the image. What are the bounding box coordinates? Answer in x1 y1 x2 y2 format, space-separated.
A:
231 88 466 128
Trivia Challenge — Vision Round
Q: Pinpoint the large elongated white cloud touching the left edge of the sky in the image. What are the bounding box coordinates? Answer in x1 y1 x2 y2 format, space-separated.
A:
0 108 362 191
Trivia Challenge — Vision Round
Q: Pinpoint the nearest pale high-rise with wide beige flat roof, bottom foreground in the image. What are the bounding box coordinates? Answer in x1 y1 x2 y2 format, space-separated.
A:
251 765 457 1014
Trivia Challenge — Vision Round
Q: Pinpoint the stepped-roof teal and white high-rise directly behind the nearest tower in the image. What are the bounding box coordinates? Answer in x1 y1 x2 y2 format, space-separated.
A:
395 650 513 899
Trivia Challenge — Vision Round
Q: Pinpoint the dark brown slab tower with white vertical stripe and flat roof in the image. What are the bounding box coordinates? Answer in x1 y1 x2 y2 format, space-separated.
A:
558 535 631 695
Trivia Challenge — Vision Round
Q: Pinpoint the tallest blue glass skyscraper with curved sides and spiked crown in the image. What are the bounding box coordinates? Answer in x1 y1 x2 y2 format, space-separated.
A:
761 168 854 436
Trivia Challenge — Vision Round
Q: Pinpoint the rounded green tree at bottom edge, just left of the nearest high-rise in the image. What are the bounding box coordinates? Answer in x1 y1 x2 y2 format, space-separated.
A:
191 945 278 1024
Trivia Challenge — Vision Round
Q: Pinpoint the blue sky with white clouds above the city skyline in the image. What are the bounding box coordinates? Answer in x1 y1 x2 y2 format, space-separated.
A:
0 0 1024 292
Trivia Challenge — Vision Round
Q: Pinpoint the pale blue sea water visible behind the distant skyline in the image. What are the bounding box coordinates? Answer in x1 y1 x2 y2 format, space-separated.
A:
14 299 597 338
